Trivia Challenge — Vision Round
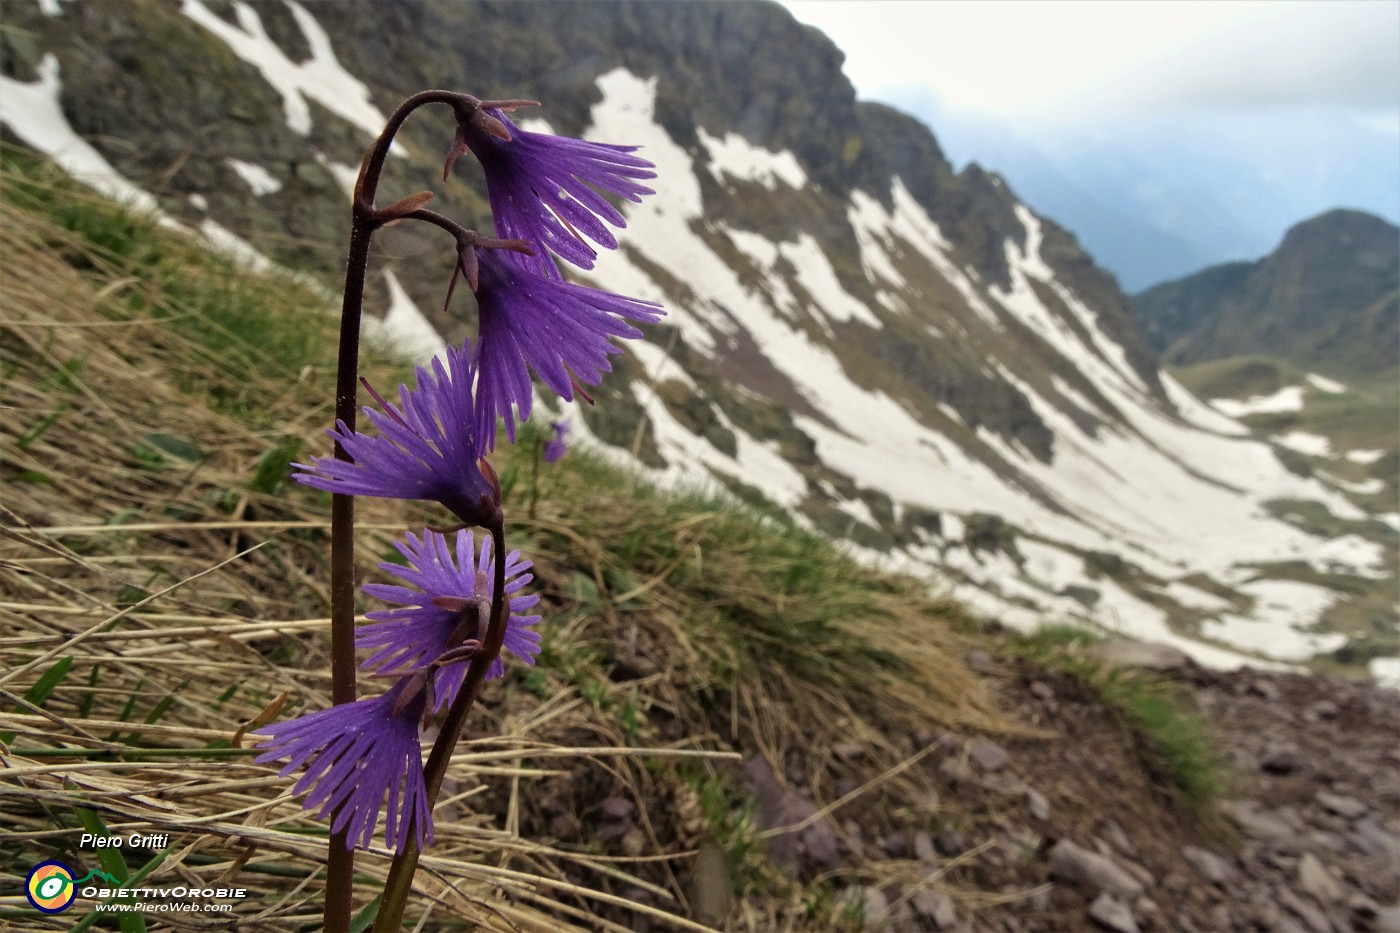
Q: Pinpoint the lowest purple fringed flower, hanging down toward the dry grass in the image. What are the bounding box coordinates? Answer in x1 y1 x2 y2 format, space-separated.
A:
253 678 433 852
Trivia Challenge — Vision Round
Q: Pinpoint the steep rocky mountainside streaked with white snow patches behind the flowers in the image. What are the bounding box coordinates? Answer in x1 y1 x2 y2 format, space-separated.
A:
0 0 1394 675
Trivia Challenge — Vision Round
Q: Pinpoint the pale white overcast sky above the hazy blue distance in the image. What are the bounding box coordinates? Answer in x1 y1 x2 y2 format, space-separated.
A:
781 0 1400 136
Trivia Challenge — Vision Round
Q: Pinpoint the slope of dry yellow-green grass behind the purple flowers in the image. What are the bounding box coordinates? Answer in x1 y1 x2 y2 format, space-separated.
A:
0 158 1220 930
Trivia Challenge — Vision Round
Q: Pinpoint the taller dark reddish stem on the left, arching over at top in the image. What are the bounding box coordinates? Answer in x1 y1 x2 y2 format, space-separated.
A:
325 91 494 933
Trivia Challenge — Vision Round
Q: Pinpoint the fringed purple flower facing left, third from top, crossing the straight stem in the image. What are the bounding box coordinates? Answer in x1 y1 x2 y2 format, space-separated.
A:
293 346 500 525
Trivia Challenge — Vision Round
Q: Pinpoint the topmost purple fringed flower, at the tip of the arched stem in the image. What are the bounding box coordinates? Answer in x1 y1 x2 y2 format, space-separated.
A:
448 108 657 277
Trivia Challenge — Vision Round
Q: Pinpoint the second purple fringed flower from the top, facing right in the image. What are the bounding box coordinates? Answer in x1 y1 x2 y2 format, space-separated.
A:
476 249 665 450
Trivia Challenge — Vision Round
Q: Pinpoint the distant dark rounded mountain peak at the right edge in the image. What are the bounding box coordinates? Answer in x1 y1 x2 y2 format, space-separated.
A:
1133 210 1400 371
